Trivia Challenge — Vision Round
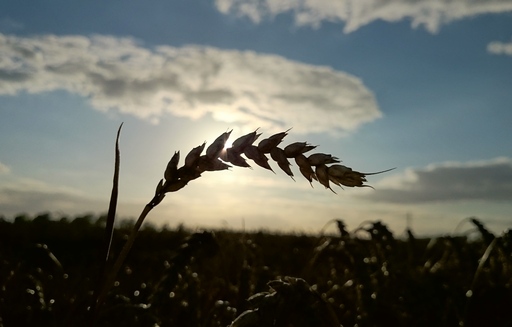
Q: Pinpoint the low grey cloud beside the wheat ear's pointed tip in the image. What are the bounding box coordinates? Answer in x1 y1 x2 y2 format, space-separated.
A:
365 158 512 204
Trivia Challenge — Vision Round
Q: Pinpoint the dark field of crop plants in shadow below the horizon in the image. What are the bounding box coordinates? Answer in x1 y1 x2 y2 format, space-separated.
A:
0 214 512 327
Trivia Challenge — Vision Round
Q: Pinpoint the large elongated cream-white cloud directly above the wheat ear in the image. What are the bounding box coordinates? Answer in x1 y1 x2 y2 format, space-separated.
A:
0 34 381 133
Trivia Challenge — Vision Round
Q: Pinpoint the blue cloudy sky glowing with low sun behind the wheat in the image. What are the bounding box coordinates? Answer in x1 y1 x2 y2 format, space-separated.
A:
0 0 512 236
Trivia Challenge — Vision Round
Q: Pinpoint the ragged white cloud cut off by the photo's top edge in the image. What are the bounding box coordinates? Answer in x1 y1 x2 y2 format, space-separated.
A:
215 0 512 33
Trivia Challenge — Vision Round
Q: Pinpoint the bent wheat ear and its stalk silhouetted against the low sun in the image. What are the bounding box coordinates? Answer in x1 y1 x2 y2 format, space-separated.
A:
92 126 394 322
